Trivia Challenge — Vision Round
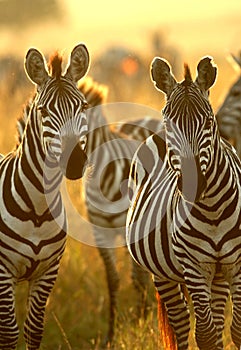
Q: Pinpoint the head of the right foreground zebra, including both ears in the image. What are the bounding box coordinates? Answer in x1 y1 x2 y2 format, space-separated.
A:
151 57 216 202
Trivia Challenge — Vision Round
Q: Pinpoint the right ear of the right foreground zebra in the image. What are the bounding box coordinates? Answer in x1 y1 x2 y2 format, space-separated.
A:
196 57 217 91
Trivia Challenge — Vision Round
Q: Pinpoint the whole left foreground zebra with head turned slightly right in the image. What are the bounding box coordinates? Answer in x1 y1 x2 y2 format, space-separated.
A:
0 44 89 350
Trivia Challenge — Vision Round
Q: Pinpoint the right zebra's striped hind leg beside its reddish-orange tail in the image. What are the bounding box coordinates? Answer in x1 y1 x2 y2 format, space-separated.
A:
154 277 190 350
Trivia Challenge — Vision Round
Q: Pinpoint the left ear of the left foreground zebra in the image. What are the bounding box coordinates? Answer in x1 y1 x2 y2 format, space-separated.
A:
25 49 48 86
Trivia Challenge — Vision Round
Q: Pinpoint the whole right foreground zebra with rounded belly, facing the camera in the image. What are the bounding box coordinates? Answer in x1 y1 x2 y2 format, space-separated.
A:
126 57 241 350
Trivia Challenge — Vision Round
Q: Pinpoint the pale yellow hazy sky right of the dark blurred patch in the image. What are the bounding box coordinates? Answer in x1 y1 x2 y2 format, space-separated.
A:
62 0 241 58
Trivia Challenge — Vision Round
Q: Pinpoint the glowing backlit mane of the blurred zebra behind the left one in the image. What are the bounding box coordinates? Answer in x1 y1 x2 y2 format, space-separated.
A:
78 77 108 107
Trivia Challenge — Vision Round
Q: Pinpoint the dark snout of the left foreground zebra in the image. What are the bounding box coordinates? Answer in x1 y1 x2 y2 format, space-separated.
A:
59 138 87 180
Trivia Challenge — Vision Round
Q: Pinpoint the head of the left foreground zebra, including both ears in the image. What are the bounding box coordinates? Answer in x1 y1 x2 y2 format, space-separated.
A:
25 44 89 179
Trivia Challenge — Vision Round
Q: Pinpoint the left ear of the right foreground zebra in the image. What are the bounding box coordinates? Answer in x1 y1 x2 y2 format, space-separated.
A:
151 57 176 95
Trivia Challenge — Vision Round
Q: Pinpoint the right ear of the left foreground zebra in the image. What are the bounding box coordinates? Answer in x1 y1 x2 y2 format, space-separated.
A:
65 44 90 83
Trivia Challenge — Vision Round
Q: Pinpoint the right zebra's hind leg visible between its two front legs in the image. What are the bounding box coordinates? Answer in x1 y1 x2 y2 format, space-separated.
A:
211 274 229 350
